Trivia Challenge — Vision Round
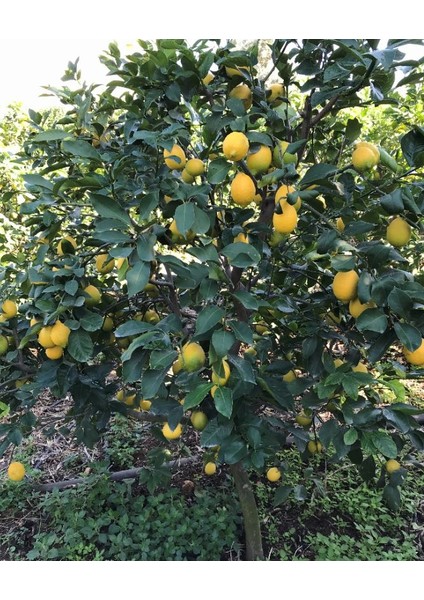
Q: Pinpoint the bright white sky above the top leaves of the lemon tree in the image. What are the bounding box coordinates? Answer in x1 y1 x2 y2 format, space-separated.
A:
0 0 423 114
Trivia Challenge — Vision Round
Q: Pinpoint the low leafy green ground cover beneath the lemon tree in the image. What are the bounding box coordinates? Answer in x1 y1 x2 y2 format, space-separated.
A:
0 406 424 561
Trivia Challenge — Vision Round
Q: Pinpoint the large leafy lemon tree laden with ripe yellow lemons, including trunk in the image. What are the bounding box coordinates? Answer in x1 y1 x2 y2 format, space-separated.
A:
0 39 424 559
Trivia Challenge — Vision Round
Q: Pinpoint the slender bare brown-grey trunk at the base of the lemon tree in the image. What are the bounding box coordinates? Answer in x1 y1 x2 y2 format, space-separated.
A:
230 462 264 560
